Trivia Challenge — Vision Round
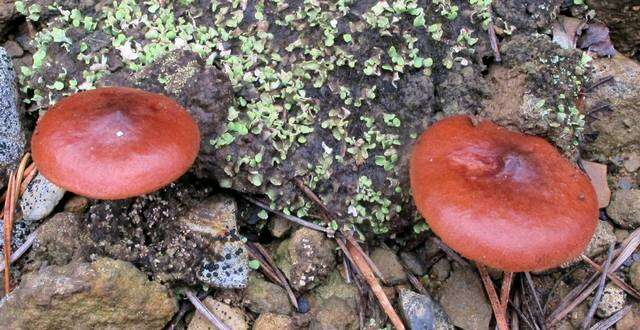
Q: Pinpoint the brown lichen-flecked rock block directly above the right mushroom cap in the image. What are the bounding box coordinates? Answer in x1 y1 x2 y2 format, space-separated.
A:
478 35 589 155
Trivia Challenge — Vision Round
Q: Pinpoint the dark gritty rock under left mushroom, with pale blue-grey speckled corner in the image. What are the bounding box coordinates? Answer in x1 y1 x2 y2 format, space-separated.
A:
84 176 247 287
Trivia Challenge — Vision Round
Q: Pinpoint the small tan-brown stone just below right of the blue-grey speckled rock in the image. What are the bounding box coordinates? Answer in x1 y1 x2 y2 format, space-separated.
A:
243 274 293 315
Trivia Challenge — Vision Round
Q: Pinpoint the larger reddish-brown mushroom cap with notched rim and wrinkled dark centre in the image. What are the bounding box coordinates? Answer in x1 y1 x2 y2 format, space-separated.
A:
410 116 598 272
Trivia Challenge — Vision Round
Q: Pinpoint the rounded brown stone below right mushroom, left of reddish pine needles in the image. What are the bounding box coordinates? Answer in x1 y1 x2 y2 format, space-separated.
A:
438 266 492 330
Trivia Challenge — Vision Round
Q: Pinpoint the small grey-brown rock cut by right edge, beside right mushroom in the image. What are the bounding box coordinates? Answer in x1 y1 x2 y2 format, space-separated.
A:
607 189 640 229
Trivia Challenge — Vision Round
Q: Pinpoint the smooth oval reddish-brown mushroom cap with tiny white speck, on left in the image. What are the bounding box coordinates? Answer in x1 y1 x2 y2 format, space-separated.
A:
31 87 200 199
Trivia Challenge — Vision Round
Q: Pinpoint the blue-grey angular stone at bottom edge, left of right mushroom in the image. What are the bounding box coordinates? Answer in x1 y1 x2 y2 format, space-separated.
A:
399 290 454 330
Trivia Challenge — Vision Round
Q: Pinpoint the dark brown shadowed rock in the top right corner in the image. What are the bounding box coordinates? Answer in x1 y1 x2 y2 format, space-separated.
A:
586 0 640 56
